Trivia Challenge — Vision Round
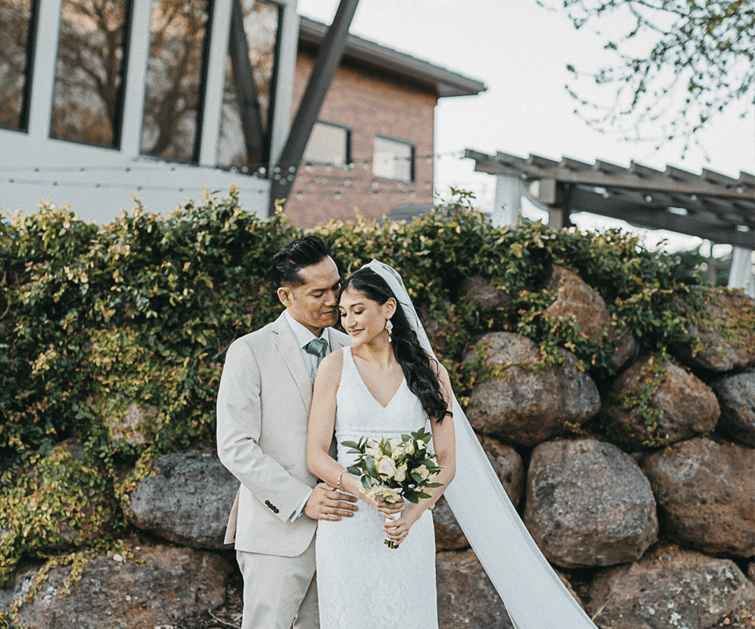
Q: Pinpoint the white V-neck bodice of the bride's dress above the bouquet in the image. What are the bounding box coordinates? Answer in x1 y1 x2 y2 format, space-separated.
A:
335 347 427 458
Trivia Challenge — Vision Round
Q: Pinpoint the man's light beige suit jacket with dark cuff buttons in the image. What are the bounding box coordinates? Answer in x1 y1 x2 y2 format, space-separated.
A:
217 315 351 557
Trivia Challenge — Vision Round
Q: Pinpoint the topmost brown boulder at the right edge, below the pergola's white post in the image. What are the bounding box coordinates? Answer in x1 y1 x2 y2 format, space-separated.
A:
676 289 755 373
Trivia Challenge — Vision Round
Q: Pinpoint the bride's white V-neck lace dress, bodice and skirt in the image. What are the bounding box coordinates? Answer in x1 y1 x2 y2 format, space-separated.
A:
316 348 438 629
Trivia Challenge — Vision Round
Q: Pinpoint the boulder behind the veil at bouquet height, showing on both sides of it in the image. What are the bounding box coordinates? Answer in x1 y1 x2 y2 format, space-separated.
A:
433 435 524 550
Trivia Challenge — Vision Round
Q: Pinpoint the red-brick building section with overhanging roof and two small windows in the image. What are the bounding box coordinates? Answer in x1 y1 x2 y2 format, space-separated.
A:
285 18 485 226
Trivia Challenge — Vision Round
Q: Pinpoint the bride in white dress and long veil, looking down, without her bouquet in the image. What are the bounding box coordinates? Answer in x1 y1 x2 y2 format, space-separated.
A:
307 260 594 629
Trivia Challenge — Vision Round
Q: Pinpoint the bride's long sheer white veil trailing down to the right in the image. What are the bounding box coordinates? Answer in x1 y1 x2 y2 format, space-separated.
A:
365 260 595 629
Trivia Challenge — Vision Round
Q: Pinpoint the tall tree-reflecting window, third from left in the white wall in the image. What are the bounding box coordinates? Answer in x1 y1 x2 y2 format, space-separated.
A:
141 0 208 161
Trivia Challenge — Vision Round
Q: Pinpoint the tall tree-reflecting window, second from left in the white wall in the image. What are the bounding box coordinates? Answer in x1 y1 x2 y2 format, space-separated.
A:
50 0 129 146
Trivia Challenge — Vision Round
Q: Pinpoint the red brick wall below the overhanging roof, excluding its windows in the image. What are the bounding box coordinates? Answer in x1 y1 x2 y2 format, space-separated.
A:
285 49 437 227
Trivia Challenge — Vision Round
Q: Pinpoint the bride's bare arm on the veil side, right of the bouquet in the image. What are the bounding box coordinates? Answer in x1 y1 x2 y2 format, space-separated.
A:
383 363 456 543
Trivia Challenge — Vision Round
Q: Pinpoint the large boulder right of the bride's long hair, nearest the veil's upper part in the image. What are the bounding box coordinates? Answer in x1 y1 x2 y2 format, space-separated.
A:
464 332 600 446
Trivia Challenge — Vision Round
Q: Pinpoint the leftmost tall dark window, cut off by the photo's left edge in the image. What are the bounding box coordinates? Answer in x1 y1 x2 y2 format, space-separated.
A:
0 0 33 130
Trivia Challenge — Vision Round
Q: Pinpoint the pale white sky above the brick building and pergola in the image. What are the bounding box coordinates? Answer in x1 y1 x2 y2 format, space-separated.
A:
298 0 755 255
